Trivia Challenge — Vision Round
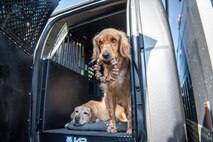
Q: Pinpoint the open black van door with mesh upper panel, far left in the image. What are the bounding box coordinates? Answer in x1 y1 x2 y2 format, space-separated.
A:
0 0 58 142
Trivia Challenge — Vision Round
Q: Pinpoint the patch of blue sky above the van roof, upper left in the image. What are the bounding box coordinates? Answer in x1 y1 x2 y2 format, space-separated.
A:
55 0 85 12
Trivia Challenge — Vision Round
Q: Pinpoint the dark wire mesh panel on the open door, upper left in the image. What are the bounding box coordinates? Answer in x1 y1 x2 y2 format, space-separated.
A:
0 0 58 54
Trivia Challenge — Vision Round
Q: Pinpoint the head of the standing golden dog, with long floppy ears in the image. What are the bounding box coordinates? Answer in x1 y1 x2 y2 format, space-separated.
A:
92 28 130 63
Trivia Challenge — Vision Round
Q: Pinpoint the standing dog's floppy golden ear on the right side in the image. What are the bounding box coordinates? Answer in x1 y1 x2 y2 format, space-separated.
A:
119 31 131 59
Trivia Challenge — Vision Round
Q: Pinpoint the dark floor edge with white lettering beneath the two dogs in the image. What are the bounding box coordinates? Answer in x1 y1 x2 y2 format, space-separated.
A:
40 128 134 142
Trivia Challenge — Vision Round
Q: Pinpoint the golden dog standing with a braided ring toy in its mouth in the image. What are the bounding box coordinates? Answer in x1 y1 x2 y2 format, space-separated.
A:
92 28 132 134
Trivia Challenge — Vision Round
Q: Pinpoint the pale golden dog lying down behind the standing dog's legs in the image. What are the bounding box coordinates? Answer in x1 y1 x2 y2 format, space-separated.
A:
70 100 127 126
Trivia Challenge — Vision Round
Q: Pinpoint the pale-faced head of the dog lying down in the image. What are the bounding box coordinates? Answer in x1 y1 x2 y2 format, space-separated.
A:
70 105 95 126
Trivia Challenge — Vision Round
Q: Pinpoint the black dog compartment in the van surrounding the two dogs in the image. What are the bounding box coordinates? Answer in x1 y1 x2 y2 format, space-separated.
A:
36 1 139 142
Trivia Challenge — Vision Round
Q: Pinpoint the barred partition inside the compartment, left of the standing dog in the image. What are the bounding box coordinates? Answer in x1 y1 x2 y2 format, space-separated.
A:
48 32 102 99
